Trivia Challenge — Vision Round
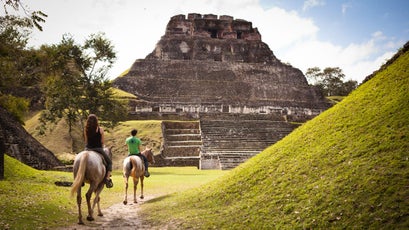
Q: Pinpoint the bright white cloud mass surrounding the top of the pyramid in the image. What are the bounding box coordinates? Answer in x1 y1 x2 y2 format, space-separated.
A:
30 0 403 82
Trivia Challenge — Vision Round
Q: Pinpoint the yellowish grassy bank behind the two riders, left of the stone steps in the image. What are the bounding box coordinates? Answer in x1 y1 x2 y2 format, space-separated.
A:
25 113 163 169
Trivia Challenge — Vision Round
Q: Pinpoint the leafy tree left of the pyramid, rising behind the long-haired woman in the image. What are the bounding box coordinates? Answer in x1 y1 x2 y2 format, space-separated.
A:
41 33 127 138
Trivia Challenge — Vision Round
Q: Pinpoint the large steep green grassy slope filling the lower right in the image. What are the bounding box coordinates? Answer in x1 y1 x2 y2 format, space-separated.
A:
141 45 409 229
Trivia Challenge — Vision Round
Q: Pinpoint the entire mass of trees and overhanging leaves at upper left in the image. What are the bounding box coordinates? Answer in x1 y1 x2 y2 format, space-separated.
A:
0 0 127 130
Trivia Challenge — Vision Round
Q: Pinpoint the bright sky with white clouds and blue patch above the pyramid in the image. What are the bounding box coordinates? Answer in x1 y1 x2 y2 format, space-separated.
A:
22 0 409 83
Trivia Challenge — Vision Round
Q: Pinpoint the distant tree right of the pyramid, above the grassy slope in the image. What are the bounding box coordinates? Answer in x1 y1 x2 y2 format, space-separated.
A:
305 67 358 96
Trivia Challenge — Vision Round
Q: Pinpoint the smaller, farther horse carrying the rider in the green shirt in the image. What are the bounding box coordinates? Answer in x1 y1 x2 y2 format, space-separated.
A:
123 148 155 205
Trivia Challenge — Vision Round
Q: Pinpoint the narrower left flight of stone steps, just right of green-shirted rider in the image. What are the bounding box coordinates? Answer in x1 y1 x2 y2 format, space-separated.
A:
155 121 202 167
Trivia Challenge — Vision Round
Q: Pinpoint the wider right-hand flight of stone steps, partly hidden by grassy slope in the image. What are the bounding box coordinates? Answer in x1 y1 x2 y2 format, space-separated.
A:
200 113 297 170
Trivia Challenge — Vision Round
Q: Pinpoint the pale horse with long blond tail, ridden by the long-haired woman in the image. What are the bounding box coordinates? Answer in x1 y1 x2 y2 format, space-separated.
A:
71 147 112 224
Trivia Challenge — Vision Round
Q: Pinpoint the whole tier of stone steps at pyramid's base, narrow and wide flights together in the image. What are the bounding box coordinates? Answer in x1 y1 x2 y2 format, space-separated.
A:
156 113 297 170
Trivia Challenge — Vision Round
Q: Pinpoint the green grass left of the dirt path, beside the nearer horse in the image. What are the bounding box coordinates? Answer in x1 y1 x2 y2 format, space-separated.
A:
0 155 76 229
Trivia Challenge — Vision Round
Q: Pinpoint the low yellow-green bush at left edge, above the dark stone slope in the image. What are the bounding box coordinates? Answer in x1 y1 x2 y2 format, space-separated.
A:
0 94 29 124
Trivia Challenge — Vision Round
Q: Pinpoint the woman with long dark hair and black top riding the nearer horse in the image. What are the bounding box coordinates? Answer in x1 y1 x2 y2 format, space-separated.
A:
84 114 113 188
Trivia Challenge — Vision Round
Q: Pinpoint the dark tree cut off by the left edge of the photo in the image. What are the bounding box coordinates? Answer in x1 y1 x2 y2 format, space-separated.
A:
0 15 38 123
